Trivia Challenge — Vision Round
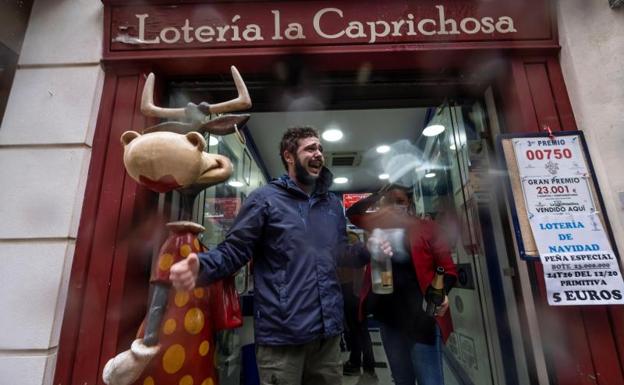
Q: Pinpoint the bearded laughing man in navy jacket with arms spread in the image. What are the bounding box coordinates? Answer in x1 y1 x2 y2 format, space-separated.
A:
171 127 392 385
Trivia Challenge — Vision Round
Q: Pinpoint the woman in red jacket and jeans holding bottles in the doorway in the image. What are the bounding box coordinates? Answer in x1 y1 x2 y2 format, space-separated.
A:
347 185 457 385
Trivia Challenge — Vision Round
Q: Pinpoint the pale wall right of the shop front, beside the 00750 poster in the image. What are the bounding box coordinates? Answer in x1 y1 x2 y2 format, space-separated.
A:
556 0 624 254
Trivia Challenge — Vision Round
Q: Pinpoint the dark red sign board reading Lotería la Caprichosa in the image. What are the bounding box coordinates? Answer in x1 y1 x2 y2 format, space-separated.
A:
107 0 552 51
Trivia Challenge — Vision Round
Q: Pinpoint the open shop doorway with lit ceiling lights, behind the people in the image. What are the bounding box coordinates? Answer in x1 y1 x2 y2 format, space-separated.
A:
169 69 537 385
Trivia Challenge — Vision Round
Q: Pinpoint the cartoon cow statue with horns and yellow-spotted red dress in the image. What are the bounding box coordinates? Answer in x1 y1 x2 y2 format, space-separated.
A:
102 66 251 385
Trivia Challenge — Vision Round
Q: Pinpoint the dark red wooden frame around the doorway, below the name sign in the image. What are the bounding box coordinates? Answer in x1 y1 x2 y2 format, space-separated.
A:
54 5 624 385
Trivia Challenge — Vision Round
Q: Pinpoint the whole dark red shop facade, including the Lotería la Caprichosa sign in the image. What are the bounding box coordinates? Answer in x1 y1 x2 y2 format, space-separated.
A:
54 0 624 385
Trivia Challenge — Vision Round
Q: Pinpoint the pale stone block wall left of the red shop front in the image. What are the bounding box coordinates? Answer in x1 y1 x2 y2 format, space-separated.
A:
0 0 103 385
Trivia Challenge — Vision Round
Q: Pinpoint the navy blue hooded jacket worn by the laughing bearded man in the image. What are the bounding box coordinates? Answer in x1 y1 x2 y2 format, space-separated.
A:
198 168 368 345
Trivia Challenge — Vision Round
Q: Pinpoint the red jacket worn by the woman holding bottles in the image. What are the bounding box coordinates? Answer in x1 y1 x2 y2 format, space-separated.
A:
349 209 457 342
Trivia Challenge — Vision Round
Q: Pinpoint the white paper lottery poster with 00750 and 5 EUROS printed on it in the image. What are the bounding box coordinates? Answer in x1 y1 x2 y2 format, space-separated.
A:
512 135 624 305
